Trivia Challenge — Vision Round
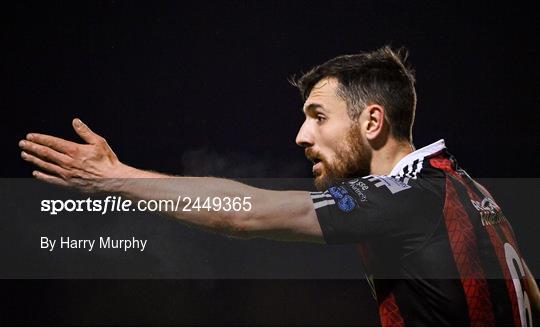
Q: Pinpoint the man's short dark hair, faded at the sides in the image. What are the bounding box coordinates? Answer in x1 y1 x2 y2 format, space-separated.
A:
291 46 416 142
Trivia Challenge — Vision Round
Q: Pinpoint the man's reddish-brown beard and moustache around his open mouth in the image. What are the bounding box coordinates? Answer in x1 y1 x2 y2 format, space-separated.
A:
305 124 372 190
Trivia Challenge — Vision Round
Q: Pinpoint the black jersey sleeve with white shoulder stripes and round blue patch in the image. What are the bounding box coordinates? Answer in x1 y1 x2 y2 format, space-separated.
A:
311 176 442 247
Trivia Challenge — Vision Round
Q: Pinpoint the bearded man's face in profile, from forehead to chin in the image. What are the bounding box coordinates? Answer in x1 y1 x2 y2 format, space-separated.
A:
296 78 372 190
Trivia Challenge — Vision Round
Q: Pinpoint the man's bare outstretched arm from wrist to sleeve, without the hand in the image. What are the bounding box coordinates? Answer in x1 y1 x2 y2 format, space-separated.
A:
99 165 324 243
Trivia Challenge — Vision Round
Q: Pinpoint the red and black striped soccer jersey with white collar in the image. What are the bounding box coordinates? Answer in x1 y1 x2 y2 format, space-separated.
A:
311 140 532 326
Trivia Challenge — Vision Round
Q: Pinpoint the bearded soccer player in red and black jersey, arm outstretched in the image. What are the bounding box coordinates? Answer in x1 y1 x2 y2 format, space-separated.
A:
20 47 539 326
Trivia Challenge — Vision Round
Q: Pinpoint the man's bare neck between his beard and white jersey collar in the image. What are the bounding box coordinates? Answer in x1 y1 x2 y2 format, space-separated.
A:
371 140 415 175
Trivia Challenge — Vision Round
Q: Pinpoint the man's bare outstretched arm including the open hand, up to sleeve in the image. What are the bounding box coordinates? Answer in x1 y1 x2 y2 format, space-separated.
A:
19 119 323 242
